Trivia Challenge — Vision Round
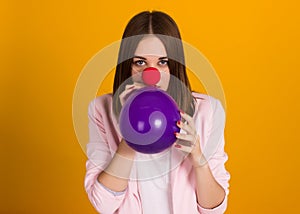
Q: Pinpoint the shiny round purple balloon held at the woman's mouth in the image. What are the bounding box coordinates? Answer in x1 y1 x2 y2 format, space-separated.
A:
119 87 180 154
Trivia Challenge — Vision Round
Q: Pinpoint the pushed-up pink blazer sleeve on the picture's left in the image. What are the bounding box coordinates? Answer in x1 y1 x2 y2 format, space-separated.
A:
84 98 126 214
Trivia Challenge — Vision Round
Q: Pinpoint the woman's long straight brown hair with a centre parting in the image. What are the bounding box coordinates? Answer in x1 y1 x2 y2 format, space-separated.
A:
113 11 195 116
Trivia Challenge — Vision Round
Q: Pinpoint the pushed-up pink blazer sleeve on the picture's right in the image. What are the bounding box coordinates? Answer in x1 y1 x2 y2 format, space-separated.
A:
198 99 230 214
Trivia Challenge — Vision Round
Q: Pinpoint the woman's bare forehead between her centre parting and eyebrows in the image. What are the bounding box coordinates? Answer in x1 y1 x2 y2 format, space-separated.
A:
134 35 167 57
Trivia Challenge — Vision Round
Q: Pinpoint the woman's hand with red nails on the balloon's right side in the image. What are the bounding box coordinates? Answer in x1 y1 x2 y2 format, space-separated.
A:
175 112 206 167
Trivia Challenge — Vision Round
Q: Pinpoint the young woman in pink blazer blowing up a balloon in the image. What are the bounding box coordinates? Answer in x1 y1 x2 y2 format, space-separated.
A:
85 11 230 214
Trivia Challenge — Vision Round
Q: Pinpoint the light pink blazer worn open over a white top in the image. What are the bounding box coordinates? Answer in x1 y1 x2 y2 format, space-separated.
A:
84 92 230 214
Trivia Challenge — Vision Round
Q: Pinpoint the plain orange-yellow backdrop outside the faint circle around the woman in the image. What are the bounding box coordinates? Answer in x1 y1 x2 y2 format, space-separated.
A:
0 0 300 214
